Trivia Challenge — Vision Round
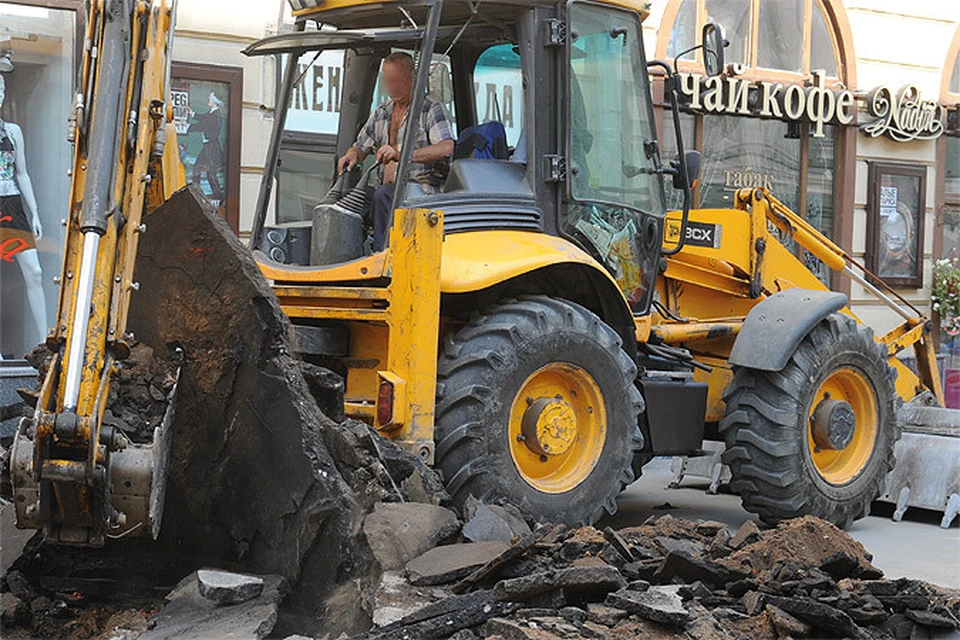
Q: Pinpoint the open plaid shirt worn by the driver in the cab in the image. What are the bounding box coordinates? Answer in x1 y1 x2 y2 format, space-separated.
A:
353 96 455 187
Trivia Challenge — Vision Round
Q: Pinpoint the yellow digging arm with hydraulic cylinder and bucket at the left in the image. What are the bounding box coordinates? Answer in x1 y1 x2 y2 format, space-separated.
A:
11 0 184 546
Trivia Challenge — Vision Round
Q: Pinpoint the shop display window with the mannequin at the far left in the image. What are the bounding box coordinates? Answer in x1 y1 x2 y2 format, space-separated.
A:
0 2 77 361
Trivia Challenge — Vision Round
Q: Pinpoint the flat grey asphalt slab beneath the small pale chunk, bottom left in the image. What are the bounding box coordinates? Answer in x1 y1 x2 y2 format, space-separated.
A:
139 573 288 640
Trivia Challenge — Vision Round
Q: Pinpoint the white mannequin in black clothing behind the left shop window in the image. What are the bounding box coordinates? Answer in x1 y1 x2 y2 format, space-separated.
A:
0 73 47 340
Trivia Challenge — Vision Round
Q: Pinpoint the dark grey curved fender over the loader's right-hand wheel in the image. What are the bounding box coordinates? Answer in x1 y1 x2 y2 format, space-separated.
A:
729 289 847 371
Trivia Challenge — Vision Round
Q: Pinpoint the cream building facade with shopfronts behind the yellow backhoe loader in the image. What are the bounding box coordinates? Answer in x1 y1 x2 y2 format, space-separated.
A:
0 0 960 384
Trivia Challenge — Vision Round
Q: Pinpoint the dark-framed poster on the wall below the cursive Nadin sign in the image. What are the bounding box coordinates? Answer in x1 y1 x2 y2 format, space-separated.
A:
867 163 926 288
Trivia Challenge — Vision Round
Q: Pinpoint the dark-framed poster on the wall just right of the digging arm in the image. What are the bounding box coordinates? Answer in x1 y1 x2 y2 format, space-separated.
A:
170 62 243 231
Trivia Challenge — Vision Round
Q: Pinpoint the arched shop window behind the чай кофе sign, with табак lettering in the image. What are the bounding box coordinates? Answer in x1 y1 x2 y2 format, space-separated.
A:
660 0 840 285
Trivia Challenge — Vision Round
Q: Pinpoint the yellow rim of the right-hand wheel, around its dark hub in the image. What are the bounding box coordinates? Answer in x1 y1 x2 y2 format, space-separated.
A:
807 369 878 485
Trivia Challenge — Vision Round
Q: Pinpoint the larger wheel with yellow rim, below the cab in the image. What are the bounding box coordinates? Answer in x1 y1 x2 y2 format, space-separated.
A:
436 296 644 524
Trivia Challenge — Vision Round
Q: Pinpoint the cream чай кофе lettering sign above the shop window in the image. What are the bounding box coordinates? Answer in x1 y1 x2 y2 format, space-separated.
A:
679 73 857 138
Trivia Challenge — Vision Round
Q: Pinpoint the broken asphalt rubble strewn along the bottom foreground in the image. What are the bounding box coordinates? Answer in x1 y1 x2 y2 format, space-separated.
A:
0 510 960 640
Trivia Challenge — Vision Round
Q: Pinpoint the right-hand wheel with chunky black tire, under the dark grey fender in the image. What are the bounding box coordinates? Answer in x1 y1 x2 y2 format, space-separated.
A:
720 313 901 528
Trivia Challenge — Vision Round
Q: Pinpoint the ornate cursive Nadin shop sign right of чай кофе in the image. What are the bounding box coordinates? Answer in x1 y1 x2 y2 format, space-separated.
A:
860 84 944 142
